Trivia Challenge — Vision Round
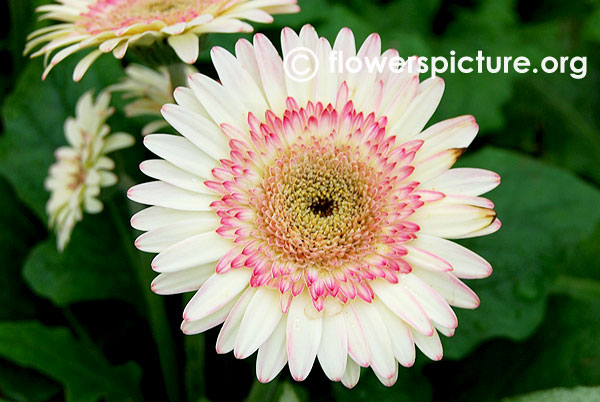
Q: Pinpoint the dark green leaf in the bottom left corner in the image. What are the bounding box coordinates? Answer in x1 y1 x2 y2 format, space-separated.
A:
0 321 141 402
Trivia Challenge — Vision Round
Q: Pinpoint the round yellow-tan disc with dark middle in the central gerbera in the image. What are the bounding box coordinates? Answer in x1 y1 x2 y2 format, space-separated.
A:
254 140 377 266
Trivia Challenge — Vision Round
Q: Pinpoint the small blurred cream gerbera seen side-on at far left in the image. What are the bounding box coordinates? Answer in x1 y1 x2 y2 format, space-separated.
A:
45 92 134 251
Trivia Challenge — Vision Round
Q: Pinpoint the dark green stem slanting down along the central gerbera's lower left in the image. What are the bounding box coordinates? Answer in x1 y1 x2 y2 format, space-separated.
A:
107 201 181 402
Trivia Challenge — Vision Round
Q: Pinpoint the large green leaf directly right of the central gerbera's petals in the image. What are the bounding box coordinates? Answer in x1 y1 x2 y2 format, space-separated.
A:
444 148 600 358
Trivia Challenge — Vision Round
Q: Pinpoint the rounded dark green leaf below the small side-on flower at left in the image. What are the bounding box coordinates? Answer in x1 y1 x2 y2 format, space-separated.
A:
23 212 142 311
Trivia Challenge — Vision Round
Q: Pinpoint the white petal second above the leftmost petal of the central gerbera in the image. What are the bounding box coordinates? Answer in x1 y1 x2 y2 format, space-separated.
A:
144 134 218 179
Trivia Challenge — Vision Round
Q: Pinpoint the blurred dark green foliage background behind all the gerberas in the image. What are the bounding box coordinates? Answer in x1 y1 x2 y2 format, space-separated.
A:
0 0 600 402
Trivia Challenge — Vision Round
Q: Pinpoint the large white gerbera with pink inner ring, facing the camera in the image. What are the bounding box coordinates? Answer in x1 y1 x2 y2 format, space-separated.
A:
129 26 500 387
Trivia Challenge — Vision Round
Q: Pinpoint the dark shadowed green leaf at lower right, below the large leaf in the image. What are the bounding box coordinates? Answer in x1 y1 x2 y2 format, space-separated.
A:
430 296 600 402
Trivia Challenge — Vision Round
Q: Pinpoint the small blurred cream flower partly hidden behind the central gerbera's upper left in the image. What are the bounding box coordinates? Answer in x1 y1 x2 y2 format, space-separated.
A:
107 64 198 135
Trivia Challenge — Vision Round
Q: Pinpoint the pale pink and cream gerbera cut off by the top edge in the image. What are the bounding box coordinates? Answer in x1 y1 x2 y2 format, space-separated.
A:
25 0 300 81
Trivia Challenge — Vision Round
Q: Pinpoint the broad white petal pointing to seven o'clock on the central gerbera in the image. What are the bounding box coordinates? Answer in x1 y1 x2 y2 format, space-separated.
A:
234 287 282 359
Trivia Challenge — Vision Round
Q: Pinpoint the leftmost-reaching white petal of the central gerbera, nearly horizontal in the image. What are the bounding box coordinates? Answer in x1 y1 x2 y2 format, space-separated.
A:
127 181 218 211
